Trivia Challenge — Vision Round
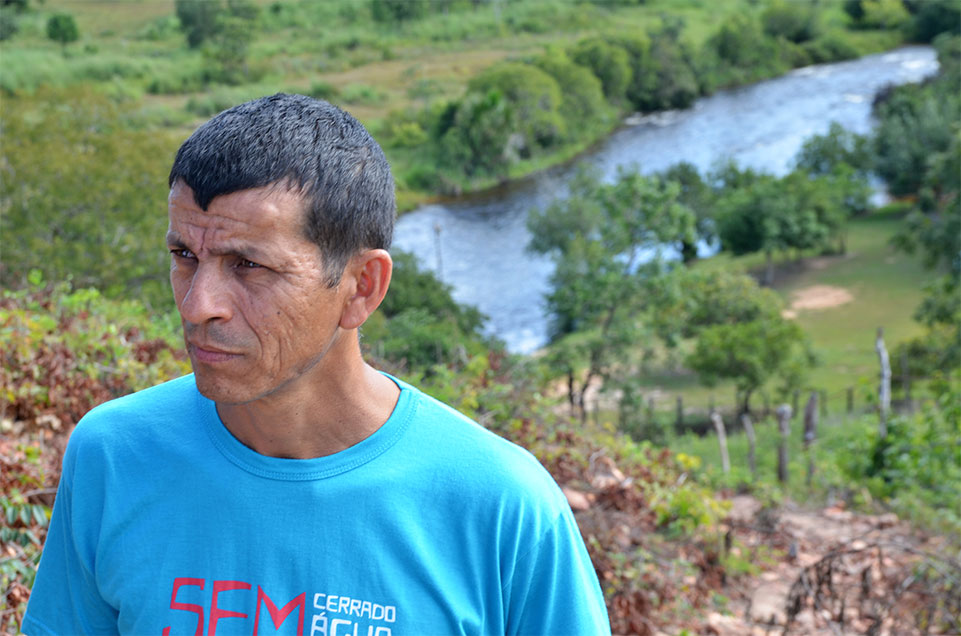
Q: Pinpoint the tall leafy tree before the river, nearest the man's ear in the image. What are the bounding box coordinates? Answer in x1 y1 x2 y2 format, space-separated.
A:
528 170 694 418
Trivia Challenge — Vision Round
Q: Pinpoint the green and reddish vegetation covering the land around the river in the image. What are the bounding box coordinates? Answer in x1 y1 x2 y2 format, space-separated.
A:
0 0 961 635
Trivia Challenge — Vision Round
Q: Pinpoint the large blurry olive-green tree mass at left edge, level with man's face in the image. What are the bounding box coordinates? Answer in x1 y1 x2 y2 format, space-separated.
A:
0 90 176 307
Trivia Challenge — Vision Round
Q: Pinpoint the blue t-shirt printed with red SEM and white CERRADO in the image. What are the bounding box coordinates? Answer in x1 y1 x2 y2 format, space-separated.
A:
22 376 610 636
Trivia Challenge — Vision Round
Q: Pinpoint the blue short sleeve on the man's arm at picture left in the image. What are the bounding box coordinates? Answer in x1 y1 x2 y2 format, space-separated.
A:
20 451 117 636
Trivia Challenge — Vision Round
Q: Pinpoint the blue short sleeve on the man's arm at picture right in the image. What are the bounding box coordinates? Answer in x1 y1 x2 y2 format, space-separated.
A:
505 510 611 636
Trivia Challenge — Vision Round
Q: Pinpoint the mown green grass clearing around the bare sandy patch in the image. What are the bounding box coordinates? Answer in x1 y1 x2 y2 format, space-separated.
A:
643 214 932 412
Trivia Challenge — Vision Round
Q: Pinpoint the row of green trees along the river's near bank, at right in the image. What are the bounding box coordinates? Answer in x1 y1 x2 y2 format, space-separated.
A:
528 36 961 432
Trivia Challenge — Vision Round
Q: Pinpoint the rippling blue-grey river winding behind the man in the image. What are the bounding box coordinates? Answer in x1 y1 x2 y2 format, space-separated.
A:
394 46 938 353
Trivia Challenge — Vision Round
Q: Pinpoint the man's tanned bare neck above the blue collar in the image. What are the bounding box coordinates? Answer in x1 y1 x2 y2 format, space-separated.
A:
217 339 400 459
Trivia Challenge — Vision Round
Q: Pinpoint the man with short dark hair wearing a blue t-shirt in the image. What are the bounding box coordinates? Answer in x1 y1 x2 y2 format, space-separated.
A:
22 95 609 636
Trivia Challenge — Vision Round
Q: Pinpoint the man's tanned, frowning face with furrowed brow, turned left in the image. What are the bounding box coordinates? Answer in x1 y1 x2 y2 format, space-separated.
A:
167 182 347 404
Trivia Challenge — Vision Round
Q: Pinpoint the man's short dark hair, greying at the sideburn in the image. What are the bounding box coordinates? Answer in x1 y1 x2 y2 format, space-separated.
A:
169 93 397 286
